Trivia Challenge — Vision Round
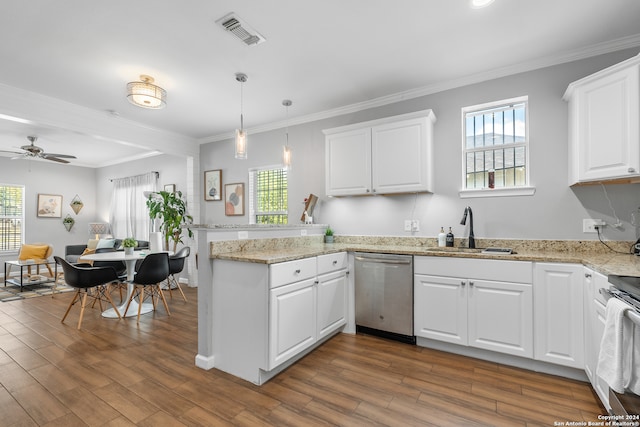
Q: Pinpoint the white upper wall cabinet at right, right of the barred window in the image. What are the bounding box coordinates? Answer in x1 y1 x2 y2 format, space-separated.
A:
563 55 640 185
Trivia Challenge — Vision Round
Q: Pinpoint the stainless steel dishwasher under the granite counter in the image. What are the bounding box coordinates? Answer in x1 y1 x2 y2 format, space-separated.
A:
355 252 416 344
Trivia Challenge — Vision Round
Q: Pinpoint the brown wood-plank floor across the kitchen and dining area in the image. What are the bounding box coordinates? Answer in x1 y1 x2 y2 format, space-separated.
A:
0 288 605 426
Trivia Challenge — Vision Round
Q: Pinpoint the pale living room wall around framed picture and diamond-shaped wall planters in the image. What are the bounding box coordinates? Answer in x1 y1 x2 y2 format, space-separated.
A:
0 157 98 262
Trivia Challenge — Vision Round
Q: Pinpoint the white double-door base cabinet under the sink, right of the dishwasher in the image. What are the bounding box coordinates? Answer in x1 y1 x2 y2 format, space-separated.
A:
414 257 533 357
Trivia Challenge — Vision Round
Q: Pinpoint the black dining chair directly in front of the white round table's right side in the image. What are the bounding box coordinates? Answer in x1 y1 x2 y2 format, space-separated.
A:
124 252 171 323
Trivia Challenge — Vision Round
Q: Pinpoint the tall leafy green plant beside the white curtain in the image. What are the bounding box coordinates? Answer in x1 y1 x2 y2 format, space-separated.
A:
147 191 193 252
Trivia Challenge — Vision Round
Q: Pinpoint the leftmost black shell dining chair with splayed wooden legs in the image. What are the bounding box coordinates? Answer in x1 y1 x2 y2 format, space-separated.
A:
53 256 121 329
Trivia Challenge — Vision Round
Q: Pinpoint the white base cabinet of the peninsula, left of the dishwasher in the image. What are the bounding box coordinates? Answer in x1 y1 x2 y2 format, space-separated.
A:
212 252 348 384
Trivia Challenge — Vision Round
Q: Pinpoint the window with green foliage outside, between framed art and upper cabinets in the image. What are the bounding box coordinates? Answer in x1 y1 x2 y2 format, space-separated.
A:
249 167 289 224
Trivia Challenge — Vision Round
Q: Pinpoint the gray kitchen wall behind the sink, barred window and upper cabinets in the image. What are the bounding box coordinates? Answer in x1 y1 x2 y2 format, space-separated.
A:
200 49 640 240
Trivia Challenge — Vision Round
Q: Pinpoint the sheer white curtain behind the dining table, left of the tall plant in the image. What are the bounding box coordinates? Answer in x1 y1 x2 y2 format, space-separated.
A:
109 172 158 241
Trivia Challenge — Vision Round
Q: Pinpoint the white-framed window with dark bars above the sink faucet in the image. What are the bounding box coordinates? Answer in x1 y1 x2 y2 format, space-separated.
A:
462 97 529 190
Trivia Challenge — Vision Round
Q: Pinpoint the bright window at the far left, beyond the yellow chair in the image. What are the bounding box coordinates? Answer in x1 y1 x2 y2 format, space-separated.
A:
0 184 24 252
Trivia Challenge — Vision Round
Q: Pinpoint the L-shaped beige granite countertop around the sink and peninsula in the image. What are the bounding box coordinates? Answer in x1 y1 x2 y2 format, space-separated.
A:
212 243 640 276
